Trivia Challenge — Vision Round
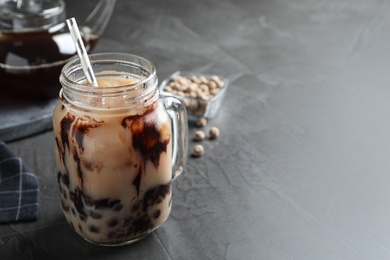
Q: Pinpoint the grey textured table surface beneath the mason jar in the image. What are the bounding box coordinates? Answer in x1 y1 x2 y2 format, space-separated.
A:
0 0 390 259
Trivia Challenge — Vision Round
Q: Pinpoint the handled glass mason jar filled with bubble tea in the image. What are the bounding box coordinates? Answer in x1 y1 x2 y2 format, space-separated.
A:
53 53 188 245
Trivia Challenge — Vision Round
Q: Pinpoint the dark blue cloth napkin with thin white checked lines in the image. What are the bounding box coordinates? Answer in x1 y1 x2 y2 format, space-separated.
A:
0 140 39 223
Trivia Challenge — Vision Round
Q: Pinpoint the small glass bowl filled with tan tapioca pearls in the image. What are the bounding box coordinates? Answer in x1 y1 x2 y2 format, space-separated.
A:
159 71 229 120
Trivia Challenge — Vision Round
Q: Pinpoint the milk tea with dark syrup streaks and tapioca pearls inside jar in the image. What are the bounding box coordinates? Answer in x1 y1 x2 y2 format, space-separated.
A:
53 76 172 245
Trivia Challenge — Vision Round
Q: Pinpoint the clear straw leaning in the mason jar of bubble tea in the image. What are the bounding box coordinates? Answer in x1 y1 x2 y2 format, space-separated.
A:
66 18 98 86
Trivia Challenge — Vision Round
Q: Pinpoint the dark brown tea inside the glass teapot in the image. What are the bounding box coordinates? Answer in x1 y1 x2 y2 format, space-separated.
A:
0 28 98 100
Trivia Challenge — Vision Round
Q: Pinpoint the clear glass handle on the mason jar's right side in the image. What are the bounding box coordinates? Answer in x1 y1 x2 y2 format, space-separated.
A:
161 96 188 180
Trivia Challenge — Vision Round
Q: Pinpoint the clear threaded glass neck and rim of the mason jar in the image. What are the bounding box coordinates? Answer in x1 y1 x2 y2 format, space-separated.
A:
60 52 159 109
